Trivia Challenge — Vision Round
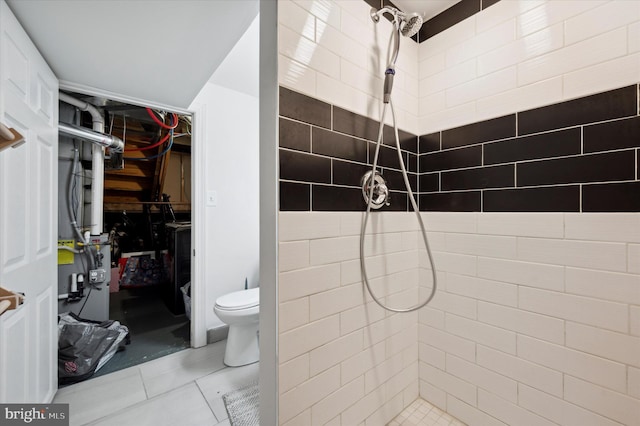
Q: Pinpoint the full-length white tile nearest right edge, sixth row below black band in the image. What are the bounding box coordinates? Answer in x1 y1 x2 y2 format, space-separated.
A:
518 335 627 392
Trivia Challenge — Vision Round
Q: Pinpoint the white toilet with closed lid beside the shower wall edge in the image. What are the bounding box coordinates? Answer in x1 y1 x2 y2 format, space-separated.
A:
213 287 260 367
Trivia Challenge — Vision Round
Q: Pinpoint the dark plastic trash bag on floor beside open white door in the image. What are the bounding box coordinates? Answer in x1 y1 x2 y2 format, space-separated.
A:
58 313 129 385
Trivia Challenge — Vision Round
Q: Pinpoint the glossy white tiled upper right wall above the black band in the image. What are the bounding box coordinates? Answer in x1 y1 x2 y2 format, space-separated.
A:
418 0 640 135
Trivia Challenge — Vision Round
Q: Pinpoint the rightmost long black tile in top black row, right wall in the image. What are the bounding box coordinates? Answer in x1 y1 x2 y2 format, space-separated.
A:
518 85 638 135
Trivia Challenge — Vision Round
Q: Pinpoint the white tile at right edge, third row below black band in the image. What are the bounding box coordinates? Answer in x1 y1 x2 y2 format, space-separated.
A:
565 268 640 305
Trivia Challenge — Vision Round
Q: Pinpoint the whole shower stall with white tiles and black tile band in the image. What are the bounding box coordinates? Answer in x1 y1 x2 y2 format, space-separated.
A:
278 0 640 425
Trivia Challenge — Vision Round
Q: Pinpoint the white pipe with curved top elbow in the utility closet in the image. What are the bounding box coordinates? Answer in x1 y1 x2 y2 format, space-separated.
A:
60 92 104 235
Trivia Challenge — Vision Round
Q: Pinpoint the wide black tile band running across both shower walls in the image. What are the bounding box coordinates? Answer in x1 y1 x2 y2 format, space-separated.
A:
280 84 640 212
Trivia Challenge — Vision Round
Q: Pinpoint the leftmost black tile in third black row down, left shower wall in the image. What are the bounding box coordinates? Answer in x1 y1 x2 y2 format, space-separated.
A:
280 149 331 183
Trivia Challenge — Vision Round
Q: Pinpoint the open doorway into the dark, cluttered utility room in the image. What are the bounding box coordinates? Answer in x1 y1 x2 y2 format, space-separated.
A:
58 92 192 376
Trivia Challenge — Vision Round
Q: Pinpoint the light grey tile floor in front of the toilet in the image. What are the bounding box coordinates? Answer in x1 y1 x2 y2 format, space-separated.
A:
53 341 258 426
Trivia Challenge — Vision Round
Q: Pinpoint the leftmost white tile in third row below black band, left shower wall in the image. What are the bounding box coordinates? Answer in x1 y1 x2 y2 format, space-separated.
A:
278 263 340 302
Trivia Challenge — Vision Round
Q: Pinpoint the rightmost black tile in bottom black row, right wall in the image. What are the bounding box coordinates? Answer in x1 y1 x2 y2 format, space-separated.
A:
582 181 640 212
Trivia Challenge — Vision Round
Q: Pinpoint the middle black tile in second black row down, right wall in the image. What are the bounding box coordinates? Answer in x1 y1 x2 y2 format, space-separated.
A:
484 128 580 164
